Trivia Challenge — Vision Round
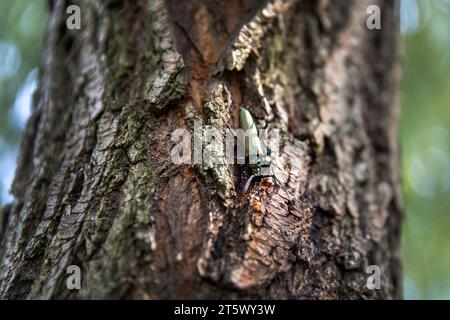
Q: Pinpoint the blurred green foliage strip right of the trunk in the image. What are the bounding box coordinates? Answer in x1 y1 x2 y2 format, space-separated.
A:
401 0 450 299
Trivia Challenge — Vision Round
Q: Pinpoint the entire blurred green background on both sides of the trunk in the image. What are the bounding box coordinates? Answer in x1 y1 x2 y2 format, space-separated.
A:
0 0 450 299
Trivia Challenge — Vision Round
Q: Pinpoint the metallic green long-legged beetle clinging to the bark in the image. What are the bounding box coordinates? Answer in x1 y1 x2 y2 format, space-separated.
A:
239 106 281 193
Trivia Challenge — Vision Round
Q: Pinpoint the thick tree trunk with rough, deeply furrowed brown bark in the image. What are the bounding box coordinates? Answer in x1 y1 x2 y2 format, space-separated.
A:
0 0 401 299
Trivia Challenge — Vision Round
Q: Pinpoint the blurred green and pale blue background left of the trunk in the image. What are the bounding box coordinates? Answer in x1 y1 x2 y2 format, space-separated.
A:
0 0 47 205
